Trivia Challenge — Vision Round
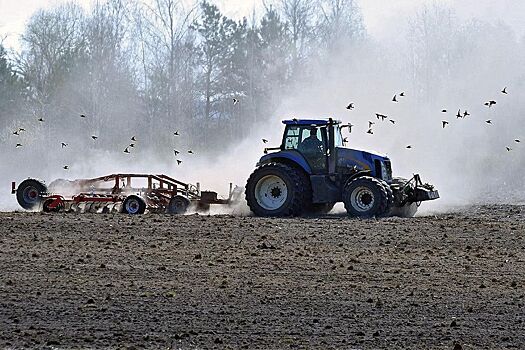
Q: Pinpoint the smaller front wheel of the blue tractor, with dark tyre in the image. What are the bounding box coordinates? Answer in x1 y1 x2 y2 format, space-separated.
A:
343 176 392 218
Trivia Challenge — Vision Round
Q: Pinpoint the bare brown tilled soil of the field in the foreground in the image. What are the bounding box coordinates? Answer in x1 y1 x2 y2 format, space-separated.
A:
0 206 525 349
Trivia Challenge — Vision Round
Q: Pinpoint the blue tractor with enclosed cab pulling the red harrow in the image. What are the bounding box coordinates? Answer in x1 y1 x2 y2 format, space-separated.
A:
245 118 439 217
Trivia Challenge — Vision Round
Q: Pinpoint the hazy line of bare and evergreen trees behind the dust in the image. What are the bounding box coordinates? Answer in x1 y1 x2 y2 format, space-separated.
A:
0 0 366 156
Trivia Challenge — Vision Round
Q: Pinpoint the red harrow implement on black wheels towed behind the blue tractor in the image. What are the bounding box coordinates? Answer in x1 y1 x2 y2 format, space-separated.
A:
11 174 240 214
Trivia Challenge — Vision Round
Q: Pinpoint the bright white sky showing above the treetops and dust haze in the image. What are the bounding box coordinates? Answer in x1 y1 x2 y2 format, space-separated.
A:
0 0 525 48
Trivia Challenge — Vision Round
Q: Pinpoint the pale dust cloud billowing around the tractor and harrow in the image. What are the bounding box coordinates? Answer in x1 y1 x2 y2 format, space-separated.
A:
0 1 525 214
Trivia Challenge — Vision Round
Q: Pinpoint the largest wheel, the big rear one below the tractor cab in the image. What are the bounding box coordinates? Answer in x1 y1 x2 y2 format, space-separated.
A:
245 163 311 217
